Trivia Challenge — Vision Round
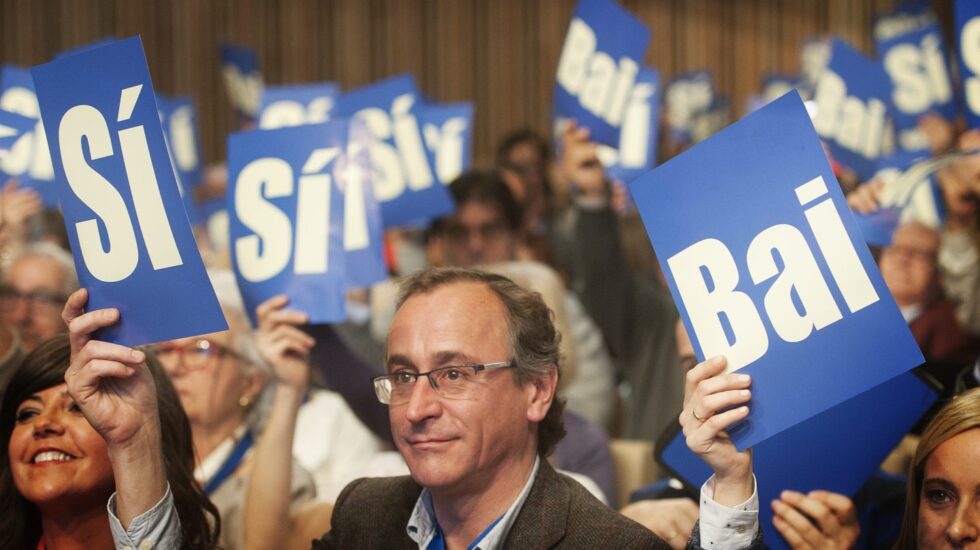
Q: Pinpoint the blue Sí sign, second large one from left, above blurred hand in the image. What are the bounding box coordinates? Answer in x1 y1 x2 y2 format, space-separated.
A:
228 120 350 325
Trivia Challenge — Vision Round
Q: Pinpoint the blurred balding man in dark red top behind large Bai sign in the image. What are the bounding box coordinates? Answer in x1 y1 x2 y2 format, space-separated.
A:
878 222 977 387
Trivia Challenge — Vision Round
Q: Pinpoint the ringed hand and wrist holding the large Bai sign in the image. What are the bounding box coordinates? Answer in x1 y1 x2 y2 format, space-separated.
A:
679 355 755 506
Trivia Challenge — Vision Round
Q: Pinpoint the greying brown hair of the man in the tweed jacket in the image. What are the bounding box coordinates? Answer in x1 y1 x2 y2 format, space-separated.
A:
396 267 565 456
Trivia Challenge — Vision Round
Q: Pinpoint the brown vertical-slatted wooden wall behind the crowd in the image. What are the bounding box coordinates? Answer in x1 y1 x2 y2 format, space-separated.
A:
0 0 951 170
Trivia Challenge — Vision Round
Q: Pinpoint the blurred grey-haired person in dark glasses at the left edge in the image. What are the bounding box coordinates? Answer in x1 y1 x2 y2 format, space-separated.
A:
0 243 78 394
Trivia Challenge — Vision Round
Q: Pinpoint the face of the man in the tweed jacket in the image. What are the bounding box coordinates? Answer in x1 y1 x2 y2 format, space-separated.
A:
387 282 554 495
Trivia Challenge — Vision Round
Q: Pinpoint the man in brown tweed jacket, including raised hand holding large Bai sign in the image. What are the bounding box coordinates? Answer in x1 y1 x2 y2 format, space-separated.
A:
310 268 761 549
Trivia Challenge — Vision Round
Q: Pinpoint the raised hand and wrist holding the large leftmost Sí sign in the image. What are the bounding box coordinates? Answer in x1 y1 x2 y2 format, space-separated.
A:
61 288 160 453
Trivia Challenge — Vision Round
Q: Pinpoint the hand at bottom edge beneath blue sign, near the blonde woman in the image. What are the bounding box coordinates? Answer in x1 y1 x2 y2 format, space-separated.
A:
772 491 861 550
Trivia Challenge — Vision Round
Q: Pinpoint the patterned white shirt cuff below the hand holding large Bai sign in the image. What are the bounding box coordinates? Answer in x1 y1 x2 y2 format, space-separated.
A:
700 475 759 550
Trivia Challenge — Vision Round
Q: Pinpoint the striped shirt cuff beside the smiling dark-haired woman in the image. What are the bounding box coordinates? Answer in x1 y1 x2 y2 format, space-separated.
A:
106 483 182 550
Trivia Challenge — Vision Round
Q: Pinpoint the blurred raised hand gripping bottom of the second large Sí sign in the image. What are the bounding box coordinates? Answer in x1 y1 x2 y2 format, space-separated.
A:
255 294 316 391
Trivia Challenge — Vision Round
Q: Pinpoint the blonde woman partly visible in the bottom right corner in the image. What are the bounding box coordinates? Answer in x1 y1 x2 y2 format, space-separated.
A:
895 389 980 550
